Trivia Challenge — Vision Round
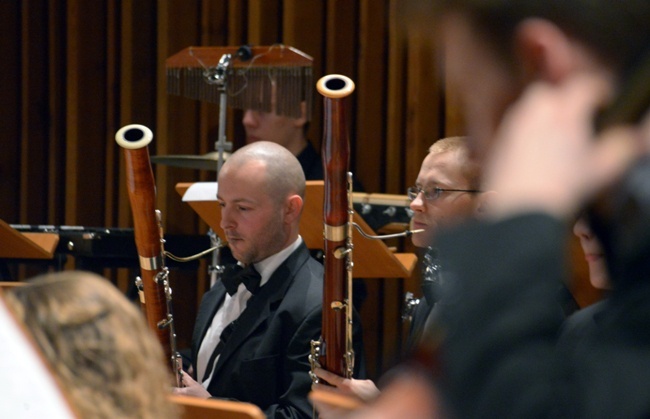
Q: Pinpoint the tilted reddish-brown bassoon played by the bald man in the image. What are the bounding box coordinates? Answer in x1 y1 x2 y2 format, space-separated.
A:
115 124 182 387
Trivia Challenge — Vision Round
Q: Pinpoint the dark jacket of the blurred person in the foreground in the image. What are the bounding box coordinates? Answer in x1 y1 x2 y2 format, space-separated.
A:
438 214 650 419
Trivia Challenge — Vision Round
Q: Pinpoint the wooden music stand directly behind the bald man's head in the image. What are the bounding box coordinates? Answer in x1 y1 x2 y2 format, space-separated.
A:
176 180 417 278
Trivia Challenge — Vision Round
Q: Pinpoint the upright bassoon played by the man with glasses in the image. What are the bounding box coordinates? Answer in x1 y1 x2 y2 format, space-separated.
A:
311 74 354 380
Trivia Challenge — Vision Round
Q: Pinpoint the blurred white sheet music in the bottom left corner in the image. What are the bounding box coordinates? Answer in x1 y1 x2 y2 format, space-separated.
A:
0 295 75 419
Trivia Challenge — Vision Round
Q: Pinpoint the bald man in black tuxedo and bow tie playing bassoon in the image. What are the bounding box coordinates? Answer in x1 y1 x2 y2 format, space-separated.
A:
175 141 362 418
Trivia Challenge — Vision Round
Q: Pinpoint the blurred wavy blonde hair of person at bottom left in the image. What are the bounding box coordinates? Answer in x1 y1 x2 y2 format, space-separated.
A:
6 271 179 418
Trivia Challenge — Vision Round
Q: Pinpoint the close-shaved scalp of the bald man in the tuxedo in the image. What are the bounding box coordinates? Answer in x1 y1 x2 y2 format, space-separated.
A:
224 141 306 203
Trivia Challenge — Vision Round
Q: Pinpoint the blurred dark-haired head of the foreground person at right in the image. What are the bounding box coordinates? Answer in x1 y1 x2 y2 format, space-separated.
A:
404 0 650 164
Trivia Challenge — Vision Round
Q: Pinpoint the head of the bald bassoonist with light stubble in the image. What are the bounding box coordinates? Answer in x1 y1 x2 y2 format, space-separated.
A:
217 141 305 264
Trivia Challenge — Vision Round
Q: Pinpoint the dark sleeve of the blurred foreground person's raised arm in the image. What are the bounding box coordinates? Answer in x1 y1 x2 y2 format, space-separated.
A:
438 214 571 418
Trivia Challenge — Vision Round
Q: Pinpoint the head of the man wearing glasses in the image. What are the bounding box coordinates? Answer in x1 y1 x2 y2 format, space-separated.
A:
411 137 479 247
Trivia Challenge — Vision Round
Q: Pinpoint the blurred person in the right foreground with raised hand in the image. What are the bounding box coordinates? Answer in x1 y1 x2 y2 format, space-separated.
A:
359 0 650 418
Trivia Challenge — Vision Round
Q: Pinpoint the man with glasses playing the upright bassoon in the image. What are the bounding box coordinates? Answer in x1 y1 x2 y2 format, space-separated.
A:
314 137 486 418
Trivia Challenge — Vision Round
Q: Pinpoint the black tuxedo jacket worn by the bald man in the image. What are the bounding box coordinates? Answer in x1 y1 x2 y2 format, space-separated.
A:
192 243 360 418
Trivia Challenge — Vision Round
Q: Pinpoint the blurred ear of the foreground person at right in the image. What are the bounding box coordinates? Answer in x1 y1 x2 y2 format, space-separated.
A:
515 18 576 83
